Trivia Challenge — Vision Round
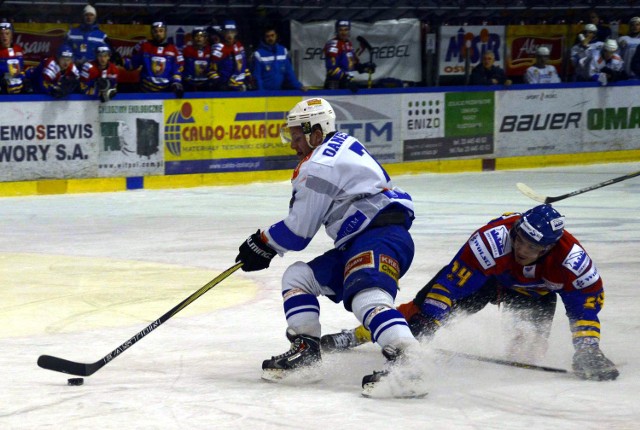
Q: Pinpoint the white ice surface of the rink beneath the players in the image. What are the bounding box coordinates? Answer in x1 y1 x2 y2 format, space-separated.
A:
0 163 640 430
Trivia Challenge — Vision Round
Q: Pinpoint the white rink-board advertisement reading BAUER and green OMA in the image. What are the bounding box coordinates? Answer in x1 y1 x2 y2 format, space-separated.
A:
495 87 640 157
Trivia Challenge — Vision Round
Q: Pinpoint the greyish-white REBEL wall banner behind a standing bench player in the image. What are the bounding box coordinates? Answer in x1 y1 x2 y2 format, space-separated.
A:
291 19 422 87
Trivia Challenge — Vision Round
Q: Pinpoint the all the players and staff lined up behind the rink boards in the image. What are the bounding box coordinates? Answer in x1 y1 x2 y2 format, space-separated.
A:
0 5 640 102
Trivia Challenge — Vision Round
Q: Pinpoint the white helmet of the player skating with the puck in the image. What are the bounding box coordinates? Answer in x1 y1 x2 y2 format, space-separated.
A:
280 97 336 143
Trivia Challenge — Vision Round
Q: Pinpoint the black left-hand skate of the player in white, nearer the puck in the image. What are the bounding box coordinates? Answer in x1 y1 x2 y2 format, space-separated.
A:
262 329 322 382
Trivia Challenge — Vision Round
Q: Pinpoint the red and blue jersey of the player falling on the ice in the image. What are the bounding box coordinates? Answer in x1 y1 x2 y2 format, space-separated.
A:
421 213 604 344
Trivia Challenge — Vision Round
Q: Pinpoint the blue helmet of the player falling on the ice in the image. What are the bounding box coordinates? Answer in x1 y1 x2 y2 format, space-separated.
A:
514 204 564 247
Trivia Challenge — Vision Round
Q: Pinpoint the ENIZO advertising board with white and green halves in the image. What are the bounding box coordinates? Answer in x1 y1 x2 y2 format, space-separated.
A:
402 92 494 161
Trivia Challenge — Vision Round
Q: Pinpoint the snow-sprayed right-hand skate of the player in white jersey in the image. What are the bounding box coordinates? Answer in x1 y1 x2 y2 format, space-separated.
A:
362 345 428 399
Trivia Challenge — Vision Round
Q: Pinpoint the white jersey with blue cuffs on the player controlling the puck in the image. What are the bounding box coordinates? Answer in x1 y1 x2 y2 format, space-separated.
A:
264 132 413 255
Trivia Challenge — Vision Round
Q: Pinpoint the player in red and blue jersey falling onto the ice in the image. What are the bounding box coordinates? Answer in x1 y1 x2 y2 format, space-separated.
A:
322 205 619 380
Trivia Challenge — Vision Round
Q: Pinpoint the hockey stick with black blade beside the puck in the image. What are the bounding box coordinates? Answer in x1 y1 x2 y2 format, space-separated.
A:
38 263 242 376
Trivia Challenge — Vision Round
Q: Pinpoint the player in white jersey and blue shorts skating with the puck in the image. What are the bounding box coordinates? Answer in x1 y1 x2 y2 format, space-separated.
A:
236 98 424 397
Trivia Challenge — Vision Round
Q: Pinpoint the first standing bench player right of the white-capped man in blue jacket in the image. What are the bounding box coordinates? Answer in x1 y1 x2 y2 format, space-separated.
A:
130 21 184 98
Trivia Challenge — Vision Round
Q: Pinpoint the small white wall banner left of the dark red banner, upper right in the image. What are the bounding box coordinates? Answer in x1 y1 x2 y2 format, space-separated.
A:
438 25 505 77
